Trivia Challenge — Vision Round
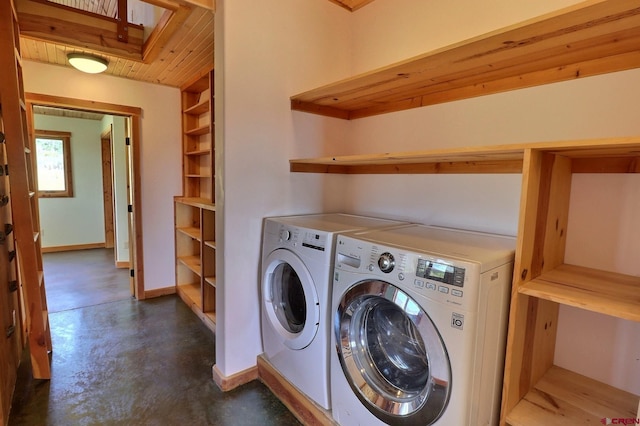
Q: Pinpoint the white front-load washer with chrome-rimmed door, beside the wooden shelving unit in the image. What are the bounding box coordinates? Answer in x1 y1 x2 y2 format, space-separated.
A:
330 225 515 426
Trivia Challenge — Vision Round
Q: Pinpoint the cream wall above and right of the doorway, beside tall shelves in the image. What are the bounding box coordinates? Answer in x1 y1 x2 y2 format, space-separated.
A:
24 61 182 291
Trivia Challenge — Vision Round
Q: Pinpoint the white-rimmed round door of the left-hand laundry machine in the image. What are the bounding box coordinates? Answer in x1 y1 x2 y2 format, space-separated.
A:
262 249 320 349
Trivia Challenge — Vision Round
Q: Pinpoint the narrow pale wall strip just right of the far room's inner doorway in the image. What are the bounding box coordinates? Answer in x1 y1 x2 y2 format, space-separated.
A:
101 115 129 262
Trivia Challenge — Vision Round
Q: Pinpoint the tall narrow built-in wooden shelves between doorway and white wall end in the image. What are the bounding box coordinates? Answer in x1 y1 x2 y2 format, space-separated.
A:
174 66 216 331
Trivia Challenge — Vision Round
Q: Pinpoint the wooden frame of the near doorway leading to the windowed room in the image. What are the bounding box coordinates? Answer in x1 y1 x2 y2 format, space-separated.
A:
25 93 145 300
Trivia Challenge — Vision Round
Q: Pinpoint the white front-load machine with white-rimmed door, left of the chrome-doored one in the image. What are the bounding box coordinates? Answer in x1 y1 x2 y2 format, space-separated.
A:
261 213 407 410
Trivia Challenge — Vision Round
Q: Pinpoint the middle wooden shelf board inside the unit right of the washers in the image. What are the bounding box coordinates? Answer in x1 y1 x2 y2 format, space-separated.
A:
518 264 640 321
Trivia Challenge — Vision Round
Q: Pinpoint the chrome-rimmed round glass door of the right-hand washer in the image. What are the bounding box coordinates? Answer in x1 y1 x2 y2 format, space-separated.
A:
334 280 451 425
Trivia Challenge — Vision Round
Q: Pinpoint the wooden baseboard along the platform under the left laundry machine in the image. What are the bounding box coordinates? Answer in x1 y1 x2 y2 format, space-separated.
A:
258 355 337 426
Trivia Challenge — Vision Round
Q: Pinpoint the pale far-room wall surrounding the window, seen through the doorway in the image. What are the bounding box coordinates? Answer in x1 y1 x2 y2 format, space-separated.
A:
34 114 104 248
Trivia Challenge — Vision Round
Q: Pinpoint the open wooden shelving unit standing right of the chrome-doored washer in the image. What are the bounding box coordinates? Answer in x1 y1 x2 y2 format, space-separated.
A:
502 146 640 426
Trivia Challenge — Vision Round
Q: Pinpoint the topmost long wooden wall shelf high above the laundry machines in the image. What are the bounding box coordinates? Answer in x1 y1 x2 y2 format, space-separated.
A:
291 0 640 119
